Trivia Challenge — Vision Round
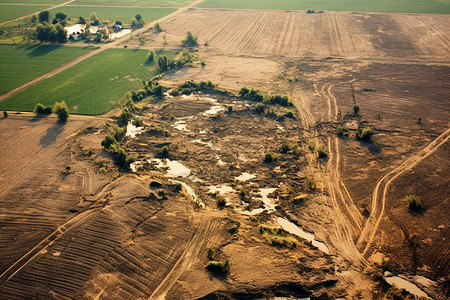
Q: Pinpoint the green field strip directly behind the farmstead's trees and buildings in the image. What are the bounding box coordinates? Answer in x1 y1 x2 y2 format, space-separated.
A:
51 6 176 24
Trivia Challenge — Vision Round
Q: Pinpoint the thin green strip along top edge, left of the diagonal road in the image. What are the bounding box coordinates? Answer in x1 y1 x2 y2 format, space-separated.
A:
71 0 193 7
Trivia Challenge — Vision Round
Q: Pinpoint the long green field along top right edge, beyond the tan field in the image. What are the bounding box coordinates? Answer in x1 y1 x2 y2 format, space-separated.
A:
199 0 450 14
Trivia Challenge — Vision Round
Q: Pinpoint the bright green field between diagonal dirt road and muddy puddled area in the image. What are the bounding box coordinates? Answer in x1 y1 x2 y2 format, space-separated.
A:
0 49 176 115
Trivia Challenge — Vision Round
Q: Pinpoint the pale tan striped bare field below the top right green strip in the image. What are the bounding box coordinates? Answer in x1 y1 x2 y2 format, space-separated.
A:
129 9 450 61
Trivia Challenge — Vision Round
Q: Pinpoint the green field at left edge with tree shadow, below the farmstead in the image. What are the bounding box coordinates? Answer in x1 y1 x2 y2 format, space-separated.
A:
0 45 90 94
